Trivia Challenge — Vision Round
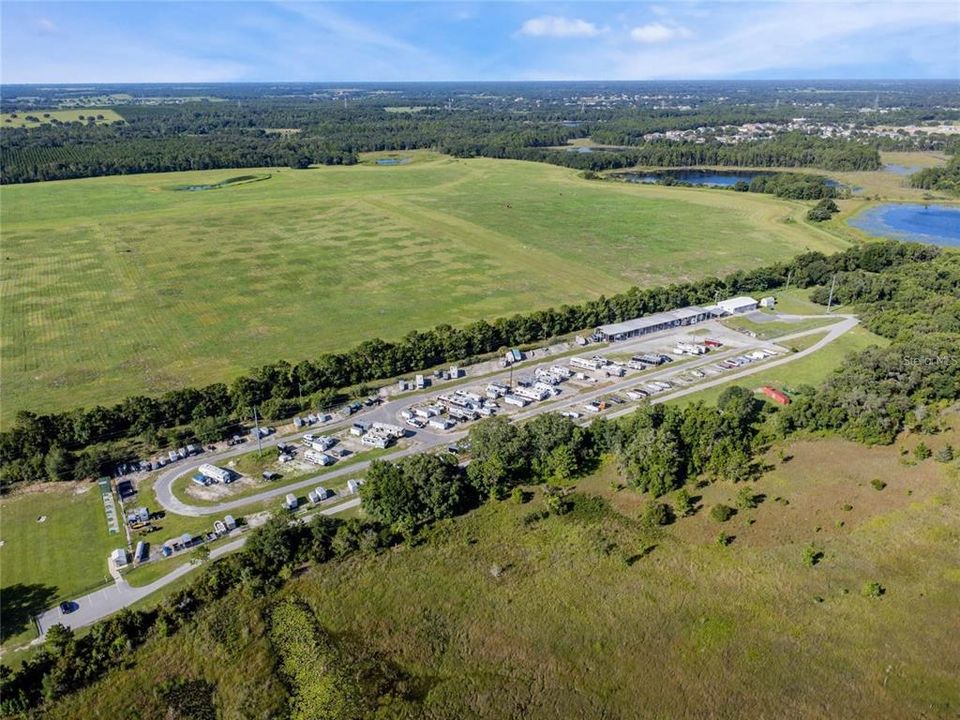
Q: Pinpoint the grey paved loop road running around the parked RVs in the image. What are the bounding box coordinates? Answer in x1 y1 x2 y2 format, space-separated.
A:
154 315 858 516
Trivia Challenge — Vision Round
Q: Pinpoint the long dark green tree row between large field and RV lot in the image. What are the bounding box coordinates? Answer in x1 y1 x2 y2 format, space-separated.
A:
0 242 938 484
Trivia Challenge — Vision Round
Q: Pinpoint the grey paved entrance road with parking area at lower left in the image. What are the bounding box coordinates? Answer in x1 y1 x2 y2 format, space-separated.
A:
31 497 360 645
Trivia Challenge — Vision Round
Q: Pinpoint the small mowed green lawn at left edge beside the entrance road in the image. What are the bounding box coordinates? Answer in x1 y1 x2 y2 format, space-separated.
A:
0 483 119 645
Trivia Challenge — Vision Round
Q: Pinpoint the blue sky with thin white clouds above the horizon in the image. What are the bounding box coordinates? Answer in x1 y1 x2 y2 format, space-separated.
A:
0 0 960 83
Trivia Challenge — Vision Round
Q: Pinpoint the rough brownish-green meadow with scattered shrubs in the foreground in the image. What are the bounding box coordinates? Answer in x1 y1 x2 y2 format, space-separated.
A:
41 429 960 719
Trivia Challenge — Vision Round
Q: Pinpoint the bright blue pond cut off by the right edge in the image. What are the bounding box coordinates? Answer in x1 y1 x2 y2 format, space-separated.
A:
848 203 960 247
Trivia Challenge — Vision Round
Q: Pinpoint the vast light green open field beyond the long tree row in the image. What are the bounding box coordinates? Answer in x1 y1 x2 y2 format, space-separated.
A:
0 153 843 423
